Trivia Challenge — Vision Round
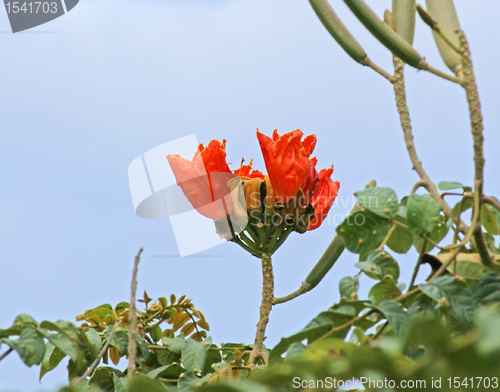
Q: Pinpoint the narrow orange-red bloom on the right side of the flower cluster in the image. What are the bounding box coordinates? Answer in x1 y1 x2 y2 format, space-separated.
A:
307 166 340 230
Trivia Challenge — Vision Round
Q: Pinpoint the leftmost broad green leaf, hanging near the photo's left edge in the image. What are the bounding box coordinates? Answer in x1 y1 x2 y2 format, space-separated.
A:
2 327 45 367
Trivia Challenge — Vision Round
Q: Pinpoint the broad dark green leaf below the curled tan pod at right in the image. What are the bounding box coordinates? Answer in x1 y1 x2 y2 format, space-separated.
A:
419 276 478 325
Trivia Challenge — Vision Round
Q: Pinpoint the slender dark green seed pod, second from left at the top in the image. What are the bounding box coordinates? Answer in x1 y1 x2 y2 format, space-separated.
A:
344 0 423 68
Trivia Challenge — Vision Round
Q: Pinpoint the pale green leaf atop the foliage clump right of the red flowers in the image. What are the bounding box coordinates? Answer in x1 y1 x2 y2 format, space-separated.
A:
354 186 399 218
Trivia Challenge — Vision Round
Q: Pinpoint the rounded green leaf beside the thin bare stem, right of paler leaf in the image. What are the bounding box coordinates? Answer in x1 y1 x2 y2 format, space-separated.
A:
406 194 442 234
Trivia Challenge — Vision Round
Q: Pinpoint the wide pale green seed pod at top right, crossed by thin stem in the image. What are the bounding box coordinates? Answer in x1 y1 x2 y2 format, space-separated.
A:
425 0 462 73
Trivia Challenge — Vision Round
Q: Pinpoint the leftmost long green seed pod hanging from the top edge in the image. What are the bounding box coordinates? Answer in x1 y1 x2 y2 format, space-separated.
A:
309 0 366 63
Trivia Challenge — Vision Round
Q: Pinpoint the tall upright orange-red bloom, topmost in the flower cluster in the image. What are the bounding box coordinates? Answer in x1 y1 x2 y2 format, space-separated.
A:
257 129 316 204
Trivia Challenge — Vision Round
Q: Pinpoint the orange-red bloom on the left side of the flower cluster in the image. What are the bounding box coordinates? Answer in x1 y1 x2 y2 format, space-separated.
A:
167 140 235 220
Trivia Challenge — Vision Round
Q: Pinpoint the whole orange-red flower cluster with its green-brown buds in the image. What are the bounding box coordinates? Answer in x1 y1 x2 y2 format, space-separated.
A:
167 129 339 253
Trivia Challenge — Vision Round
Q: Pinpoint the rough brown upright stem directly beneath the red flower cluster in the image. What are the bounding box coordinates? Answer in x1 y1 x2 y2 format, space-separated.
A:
248 253 274 365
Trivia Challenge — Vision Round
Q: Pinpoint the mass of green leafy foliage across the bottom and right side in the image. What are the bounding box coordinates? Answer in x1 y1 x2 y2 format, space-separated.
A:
0 184 500 392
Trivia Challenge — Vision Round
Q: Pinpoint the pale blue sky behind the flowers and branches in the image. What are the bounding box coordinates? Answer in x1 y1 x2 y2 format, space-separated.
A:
0 0 500 391
